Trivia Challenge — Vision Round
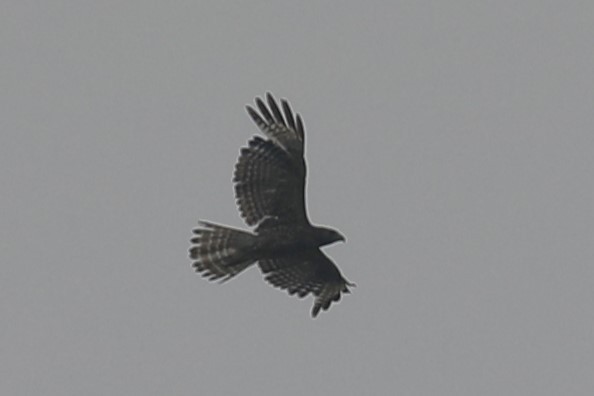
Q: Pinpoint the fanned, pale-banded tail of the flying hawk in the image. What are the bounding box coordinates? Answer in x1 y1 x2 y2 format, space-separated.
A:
190 221 258 282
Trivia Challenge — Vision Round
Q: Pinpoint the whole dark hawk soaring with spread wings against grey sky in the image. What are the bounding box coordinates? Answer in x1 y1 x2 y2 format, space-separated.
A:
190 93 354 318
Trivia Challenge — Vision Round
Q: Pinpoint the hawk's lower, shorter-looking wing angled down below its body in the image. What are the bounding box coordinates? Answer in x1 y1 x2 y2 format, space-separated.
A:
259 249 354 318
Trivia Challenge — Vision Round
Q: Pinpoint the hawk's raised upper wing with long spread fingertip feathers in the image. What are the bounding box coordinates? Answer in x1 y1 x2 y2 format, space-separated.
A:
233 94 309 225
